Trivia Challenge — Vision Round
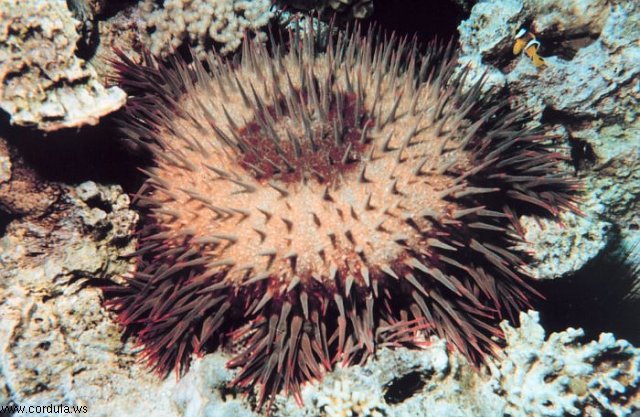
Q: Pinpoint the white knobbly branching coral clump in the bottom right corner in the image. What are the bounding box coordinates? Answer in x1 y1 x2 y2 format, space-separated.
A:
493 311 640 417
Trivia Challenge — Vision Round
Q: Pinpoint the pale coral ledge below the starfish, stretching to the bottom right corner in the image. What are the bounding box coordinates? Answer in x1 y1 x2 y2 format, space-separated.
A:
275 311 640 417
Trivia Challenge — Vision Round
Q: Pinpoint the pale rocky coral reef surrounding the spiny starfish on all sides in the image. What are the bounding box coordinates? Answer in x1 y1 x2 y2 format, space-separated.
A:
0 0 640 417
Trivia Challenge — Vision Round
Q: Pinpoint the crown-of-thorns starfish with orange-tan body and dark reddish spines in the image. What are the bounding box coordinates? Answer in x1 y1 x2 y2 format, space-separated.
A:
108 24 577 404
